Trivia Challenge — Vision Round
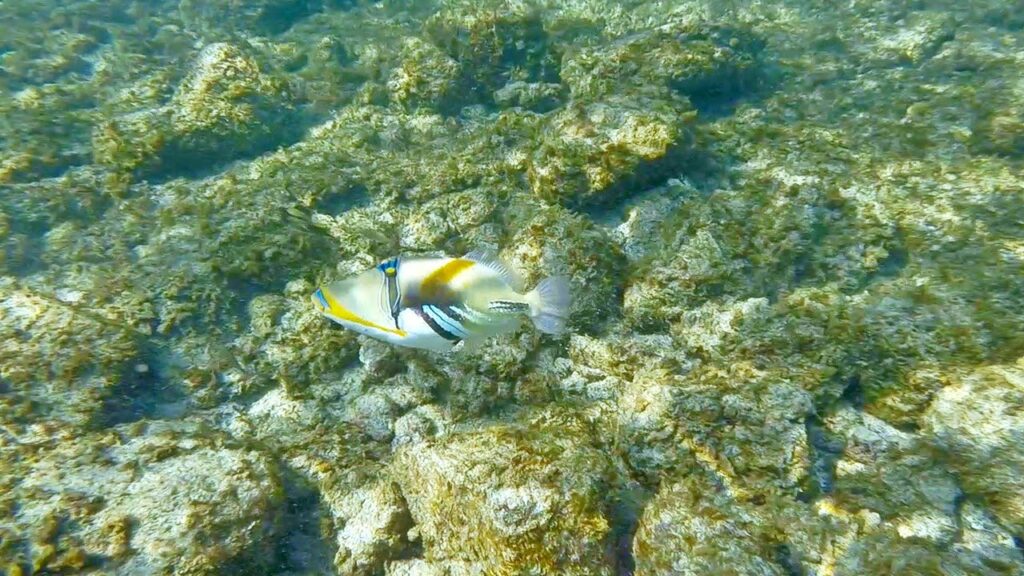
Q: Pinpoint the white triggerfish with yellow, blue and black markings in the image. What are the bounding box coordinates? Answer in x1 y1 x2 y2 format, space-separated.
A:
312 252 572 352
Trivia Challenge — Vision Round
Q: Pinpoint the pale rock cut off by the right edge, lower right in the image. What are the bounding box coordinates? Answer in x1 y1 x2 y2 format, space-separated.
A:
921 361 1024 535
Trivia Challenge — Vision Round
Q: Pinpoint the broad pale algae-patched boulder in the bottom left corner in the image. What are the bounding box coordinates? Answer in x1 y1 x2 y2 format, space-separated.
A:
8 416 284 574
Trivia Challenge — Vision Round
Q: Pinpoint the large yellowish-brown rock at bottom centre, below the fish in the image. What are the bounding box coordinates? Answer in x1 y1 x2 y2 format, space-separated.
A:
392 411 609 574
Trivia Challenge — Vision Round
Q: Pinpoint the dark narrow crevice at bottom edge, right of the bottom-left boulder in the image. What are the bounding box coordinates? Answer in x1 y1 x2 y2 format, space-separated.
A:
275 468 338 574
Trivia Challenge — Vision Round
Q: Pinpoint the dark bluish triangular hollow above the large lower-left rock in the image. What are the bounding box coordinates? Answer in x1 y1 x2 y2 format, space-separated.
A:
99 342 189 427
